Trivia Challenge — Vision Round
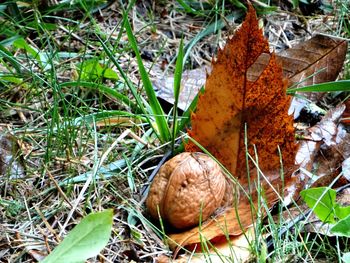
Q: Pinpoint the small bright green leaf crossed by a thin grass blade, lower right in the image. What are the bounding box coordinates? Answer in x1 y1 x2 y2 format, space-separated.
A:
300 187 336 223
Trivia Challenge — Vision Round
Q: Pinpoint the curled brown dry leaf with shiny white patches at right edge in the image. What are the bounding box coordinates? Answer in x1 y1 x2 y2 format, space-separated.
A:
296 105 350 187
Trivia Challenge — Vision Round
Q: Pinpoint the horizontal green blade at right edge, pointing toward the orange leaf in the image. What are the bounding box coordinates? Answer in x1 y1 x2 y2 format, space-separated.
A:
287 80 350 94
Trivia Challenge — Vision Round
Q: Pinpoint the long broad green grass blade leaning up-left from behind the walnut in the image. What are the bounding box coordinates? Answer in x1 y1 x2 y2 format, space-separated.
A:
123 11 171 143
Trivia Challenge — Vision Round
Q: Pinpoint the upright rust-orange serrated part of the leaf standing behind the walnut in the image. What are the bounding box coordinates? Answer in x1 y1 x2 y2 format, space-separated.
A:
186 5 296 199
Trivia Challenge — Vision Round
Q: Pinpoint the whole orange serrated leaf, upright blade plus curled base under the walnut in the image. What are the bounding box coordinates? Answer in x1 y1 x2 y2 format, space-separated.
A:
170 6 297 252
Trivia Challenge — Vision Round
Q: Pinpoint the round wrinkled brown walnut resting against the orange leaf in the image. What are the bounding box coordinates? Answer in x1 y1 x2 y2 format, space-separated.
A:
146 152 226 229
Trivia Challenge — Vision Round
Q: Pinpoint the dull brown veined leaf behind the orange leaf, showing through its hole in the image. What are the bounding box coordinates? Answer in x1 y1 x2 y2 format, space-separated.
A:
249 35 347 87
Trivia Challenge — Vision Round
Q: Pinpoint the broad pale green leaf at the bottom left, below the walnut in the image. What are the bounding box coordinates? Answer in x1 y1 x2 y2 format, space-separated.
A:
42 209 113 263
